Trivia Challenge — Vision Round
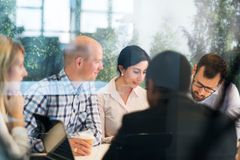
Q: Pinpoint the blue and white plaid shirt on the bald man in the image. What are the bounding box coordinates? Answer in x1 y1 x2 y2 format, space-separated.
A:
24 70 101 152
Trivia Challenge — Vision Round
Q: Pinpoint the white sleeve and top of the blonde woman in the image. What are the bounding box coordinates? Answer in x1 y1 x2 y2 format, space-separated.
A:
0 114 30 158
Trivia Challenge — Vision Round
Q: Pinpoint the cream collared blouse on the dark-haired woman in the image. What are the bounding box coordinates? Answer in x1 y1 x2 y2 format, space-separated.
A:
98 77 149 137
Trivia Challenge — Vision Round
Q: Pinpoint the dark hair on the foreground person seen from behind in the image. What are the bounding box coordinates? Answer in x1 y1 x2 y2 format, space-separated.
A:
146 51 191 92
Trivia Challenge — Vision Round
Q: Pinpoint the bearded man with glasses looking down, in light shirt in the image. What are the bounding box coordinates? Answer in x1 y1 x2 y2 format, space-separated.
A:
191 53 240 139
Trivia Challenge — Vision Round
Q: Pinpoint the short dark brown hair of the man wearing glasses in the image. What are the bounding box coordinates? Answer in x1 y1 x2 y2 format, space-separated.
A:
196 53 227 83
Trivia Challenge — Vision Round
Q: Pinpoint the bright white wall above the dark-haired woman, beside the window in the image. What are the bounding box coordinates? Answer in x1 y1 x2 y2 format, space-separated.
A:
133 0 196 54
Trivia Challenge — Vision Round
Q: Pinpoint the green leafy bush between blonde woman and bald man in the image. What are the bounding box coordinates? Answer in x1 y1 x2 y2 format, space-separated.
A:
21 37 63 81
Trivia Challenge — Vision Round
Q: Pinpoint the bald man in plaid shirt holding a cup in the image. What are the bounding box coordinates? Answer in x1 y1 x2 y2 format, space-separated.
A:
24 36 103 156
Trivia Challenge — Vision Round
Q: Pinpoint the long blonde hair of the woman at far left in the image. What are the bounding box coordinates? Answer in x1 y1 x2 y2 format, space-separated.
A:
0 34 24 114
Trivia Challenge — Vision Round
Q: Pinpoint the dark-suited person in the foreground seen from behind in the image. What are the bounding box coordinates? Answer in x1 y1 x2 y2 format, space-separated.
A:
104 51 236 160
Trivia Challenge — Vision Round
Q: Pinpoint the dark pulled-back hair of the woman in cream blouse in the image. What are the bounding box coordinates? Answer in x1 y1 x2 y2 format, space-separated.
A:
117 45 150 73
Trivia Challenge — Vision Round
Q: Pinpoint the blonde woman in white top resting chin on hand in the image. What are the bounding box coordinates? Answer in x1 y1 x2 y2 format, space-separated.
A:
0 35 30 159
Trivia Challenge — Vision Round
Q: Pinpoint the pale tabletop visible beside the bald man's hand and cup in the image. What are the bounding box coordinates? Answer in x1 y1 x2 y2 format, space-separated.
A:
75 144 110 160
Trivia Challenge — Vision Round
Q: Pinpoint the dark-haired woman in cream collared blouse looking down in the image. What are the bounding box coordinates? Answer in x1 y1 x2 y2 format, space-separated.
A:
99 45 150 142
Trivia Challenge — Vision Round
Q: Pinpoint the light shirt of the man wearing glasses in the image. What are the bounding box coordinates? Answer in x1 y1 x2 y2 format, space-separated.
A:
201 83 240 139
